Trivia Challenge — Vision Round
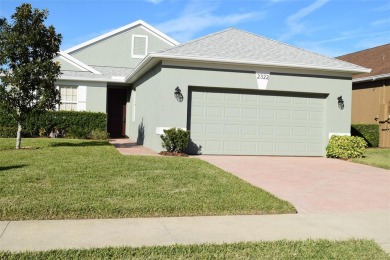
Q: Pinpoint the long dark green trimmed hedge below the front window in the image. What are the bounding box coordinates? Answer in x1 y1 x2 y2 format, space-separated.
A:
0 111 107 139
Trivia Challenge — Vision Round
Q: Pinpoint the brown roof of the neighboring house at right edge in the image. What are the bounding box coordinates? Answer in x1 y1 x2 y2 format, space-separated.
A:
337 43 390 81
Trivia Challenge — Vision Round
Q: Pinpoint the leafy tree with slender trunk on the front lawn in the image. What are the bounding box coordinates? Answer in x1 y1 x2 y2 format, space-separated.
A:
0 4 62 149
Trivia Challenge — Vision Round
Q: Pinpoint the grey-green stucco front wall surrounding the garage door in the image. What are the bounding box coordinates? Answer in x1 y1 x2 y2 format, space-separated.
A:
133 62 352 153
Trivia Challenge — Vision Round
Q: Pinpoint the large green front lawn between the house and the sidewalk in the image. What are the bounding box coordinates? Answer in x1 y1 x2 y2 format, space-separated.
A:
0 138 296 220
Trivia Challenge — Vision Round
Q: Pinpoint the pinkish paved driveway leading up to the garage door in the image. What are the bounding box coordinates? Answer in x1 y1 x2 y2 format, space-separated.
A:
199 155 390 215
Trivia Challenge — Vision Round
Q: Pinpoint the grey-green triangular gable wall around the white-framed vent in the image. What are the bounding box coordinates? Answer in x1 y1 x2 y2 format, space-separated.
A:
69 26 170 68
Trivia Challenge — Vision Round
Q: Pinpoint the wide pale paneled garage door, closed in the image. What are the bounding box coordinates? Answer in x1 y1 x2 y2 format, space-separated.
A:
189 89 325 156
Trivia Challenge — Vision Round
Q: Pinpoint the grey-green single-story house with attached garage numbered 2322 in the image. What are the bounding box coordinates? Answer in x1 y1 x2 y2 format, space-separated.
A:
57 21 370 156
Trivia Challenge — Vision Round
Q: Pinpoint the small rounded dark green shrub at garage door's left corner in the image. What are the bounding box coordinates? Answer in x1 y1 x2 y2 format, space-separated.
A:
160 128 190 153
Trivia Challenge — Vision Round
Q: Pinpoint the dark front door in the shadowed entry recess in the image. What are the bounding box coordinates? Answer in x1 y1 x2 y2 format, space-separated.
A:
107 88 127 137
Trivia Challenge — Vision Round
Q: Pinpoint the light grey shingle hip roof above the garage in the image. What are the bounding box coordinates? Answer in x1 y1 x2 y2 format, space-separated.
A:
159 28 365 71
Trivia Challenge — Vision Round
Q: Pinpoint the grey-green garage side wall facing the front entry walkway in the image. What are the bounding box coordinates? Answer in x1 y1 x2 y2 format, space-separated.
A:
126 65 161 151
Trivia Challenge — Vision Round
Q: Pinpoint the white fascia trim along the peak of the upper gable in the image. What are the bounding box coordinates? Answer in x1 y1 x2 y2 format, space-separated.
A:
63 20 179 54
